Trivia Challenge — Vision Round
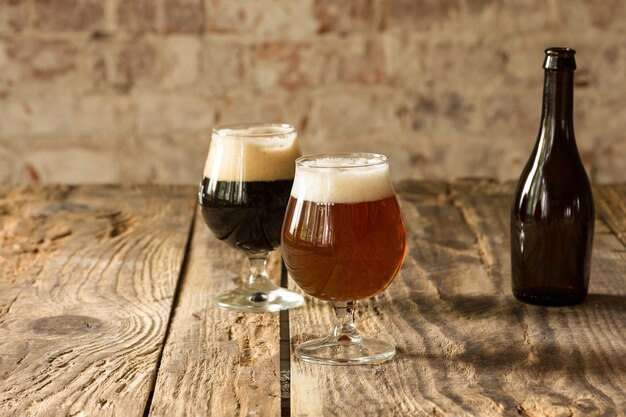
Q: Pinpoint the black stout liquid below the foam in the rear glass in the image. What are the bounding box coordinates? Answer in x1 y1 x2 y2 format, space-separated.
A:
200 178 293 252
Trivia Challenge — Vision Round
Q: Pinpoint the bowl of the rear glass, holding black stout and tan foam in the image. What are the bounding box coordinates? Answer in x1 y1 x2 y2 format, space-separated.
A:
198 125 300 254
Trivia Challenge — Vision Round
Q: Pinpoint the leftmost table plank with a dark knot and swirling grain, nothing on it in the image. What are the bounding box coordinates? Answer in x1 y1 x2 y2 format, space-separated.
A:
0 186 195 417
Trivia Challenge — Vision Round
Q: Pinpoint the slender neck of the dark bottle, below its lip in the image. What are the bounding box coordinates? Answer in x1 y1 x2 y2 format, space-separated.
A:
542 70 574 139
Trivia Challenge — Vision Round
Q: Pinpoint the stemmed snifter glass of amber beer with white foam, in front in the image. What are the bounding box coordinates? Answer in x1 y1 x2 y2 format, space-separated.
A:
281 153 406 365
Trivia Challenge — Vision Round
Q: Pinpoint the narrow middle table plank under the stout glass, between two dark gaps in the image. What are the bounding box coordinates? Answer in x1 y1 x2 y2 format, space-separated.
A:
150 208 280 417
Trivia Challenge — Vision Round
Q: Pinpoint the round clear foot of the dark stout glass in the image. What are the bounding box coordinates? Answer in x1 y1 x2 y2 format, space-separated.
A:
214 285 304 313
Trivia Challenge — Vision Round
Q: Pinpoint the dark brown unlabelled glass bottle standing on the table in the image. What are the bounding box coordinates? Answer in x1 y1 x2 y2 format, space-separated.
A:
511 48 594 306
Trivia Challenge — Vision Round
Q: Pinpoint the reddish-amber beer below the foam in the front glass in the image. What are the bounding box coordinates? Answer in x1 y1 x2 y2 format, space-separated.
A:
282 197 405 301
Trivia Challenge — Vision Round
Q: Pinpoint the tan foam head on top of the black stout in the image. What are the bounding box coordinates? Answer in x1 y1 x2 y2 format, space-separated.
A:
204 124 300 181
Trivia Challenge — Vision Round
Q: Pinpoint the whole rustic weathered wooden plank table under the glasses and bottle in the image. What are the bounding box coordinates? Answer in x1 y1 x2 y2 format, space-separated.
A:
0 180 626 417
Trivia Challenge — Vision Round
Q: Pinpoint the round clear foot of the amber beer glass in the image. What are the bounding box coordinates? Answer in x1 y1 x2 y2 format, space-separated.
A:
296 336 396 365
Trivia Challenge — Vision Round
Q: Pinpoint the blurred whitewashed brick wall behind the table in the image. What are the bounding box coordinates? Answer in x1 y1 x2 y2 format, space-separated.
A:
0 0 626 183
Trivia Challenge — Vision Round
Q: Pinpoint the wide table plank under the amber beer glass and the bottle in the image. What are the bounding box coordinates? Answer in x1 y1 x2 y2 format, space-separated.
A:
290 181 626 417
